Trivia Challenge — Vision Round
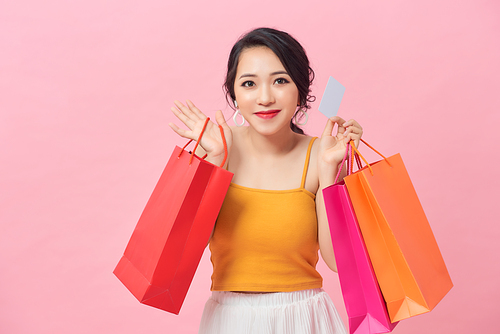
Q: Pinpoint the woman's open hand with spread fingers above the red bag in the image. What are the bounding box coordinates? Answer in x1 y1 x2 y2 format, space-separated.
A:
169 100 233 165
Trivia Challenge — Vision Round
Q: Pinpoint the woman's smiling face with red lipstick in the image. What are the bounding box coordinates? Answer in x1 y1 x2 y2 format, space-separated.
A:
234 47 299 135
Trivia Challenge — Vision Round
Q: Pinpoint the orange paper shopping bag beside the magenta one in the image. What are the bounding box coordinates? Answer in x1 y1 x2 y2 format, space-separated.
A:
344 141 453 322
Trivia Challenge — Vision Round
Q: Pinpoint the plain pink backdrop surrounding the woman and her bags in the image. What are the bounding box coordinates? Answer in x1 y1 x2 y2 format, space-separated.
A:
0 0 500 334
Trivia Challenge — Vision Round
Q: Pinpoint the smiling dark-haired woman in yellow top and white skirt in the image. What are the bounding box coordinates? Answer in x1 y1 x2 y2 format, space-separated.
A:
170 28 362 334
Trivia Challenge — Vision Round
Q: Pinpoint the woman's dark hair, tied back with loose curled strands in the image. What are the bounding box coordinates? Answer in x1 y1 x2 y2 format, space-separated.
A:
223 28 316 134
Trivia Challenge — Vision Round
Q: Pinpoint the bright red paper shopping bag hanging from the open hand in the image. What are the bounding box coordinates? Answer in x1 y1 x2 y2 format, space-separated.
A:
114 118 233 314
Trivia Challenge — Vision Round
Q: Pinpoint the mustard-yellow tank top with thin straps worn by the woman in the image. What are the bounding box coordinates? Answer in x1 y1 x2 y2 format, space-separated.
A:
210 138 323 292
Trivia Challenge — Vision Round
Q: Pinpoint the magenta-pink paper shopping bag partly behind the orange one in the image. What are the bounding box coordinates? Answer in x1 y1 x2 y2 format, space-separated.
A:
323 146 397 334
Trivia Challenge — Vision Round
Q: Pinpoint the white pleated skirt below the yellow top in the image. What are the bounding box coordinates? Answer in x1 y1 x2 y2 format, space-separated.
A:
198 289 347 334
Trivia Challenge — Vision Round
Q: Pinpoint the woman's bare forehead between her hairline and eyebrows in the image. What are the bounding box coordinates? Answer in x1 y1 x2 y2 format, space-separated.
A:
236 46 285 75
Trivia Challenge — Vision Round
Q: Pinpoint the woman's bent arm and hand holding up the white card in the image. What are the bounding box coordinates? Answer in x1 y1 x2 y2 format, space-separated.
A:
316 116 363 272
